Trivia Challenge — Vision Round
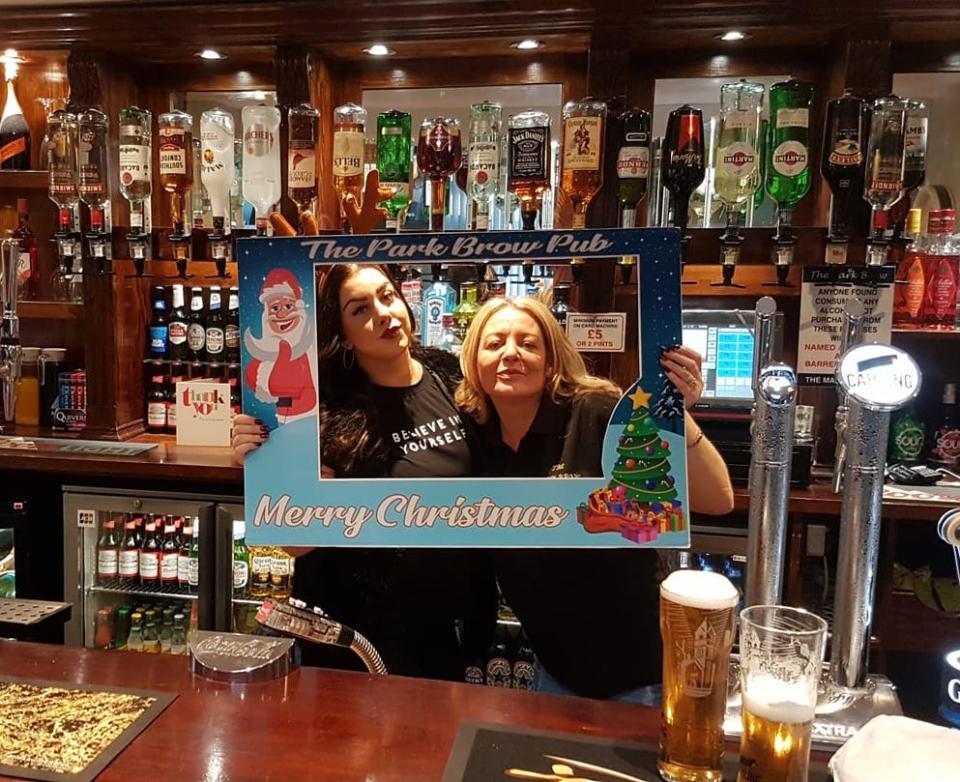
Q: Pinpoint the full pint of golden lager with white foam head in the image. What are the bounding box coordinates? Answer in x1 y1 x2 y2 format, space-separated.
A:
657 570 740 782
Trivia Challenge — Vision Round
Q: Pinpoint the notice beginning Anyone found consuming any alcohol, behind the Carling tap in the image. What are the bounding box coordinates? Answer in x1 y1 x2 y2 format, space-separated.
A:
797 266 896 386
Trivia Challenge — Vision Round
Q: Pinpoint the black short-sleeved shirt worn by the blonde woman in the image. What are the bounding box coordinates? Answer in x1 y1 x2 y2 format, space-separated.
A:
483 394 661 698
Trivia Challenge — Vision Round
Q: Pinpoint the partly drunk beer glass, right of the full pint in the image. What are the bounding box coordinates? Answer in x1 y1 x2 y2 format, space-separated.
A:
737 606 827 782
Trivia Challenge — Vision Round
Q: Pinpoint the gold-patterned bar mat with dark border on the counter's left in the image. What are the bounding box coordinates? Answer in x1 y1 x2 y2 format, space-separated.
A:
0 676 177 782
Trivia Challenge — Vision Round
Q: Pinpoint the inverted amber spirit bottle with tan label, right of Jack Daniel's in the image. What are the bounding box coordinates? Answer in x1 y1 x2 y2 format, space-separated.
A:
561 98 607 228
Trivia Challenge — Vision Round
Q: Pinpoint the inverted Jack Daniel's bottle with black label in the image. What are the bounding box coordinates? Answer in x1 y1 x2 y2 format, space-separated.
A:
507 111 550 230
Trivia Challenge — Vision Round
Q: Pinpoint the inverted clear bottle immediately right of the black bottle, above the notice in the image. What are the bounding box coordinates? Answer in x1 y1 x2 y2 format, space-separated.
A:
863 96 907 266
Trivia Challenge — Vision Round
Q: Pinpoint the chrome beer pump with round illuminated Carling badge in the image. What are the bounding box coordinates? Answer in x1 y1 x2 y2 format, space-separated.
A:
813 344 920 746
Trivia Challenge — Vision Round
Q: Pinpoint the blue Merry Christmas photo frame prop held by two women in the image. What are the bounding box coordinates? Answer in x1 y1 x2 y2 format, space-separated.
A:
237 228 690 548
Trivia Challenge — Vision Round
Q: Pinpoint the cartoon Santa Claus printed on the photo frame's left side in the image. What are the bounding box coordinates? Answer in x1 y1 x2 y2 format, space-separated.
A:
243 269 317 424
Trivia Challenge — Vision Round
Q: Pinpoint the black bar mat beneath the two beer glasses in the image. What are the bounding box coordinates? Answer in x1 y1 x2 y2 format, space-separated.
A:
443 722 830 782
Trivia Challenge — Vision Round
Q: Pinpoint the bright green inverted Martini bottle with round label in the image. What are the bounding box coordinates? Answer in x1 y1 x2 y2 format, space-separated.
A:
766 79 813 285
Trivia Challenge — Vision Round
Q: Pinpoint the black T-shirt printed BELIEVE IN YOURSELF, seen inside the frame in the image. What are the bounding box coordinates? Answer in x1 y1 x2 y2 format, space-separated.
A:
373 368 472 478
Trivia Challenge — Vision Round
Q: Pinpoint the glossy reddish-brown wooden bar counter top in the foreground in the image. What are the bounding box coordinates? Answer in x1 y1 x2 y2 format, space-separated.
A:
0 639 660 782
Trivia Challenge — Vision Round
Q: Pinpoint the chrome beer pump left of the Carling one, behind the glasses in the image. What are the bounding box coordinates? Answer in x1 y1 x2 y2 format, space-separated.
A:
745 296 797 606
